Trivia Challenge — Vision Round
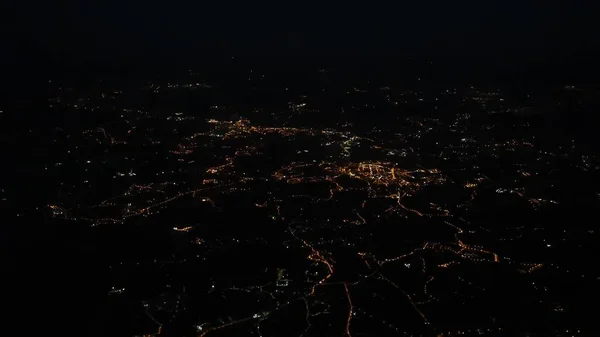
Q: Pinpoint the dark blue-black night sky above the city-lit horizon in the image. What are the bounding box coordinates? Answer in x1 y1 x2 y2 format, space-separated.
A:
2 0 600 79
